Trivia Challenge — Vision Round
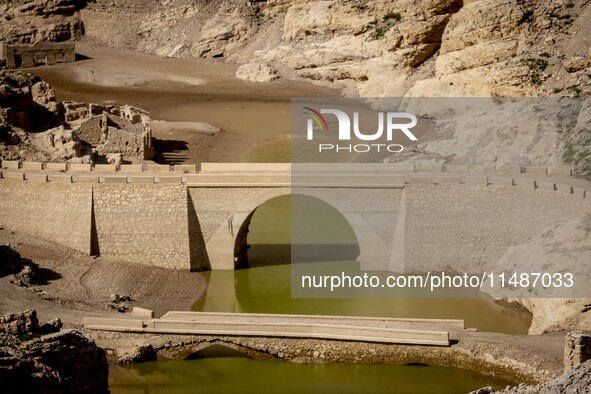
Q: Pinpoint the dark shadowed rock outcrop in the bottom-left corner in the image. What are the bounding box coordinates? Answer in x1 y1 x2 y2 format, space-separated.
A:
0 311 109 394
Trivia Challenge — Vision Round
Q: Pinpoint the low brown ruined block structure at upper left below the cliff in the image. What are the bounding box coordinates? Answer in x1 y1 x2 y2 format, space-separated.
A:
0 42 76 68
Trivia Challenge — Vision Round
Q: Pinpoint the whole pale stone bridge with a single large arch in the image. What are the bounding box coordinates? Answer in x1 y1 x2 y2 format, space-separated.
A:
0 161 591 272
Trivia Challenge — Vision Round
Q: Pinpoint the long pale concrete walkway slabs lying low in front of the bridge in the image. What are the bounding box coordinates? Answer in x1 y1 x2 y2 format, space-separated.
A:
83 312 464 346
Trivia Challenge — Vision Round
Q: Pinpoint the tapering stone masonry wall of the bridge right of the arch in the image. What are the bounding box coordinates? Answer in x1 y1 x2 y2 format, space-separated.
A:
405 184 591 272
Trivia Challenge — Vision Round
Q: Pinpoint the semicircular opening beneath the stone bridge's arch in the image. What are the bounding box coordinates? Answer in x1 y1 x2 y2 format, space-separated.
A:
234 193 360 269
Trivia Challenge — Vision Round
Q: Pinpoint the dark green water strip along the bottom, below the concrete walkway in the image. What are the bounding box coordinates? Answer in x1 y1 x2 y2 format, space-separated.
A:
109 358 508 394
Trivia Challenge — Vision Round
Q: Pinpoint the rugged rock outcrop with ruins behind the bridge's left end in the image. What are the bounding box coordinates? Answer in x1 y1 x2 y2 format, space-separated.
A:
0 72 153 164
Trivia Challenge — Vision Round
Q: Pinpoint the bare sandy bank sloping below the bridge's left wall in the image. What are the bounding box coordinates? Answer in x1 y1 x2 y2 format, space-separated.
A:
0 229 206 326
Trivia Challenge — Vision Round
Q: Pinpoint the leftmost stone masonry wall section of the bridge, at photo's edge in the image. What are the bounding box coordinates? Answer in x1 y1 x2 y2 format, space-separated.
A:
0 179 92 253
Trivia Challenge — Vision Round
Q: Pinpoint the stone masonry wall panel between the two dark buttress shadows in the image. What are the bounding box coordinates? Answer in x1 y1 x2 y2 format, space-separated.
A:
94 184 196 269
